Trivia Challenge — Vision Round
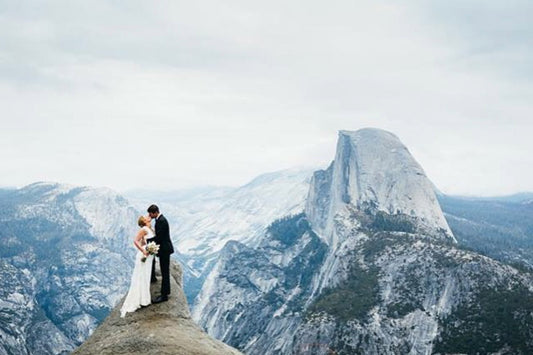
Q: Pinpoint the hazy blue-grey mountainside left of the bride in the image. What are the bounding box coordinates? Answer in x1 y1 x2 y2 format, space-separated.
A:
0 183 138 354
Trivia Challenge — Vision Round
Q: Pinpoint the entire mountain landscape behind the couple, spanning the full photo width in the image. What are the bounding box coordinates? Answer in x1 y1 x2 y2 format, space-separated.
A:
0 130 533 354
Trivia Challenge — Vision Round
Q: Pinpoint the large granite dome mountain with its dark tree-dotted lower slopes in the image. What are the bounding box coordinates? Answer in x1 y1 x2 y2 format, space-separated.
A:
193 129 533 354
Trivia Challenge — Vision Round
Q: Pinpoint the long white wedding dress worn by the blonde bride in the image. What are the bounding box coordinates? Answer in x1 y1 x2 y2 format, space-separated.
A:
120 226 154 317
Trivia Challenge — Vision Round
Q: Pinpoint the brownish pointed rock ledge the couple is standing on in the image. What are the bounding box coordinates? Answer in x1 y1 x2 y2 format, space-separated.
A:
73 262 241 355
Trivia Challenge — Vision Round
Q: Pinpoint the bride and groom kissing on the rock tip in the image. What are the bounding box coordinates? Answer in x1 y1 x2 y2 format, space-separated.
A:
120 205 174 317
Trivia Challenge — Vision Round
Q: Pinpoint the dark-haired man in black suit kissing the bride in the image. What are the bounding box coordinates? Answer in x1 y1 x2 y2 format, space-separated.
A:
147 205 174 303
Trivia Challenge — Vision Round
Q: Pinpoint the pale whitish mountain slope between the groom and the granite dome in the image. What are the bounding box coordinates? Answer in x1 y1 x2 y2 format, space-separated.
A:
172 169 312 255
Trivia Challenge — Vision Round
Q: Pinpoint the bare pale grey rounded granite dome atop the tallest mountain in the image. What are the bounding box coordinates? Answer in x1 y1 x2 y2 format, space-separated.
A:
305 128 455 248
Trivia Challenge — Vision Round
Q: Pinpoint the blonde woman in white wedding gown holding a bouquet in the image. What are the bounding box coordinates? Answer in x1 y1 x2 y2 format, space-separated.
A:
120 216 154 317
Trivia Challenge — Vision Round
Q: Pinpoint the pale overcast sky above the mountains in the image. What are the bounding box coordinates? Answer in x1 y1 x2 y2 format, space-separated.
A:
0 0 533 195
